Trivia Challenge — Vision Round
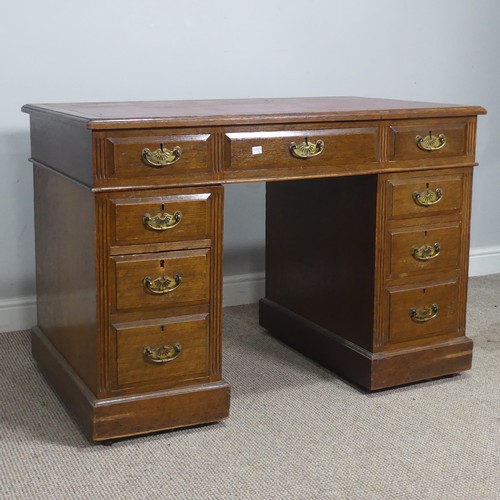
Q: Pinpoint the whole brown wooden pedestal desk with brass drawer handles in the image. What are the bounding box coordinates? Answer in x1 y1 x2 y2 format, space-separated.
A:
23 97 485 440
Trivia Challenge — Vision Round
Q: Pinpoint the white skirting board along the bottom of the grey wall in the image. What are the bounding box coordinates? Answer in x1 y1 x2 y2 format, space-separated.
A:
0 247 500 332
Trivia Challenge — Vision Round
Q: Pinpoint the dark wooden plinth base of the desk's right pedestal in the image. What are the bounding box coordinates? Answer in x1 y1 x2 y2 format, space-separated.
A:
259 299 472 391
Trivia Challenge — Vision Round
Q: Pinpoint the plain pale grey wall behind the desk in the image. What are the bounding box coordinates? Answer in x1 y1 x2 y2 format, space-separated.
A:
0 0 500 307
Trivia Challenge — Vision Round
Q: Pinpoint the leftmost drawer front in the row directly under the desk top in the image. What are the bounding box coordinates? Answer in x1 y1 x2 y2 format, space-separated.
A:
106 130 212 180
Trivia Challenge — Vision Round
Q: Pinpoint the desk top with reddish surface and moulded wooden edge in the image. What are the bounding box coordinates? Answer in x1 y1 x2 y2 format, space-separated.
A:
23 97 486 130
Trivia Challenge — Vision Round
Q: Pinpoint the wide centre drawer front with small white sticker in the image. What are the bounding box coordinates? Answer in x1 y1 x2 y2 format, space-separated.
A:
225 127 378 170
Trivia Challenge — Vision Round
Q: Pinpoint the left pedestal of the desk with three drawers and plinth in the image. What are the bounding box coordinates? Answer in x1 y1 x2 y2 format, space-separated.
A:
32 164 230 440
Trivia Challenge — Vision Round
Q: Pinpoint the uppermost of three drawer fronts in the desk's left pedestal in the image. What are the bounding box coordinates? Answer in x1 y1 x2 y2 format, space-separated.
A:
110 191 211 245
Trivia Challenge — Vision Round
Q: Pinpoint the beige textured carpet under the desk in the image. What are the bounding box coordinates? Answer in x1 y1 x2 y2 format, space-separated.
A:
0 275 500 500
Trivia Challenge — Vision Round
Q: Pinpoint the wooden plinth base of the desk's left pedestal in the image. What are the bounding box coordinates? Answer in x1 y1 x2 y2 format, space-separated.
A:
31 327 230 441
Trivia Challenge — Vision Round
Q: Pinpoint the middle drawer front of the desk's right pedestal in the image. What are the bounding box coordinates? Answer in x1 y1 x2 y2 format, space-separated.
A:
388 221 461 278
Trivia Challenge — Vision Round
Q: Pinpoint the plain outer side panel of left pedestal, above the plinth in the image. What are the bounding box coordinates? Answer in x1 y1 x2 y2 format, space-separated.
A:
34 165 98 393
